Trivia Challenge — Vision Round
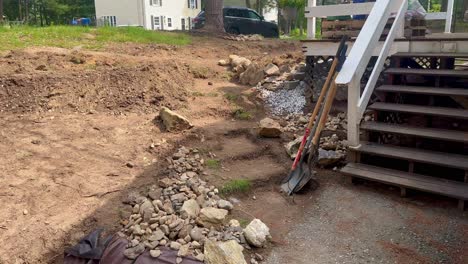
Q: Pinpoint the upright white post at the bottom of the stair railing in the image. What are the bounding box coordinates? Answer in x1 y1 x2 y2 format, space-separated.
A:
348 78 361 147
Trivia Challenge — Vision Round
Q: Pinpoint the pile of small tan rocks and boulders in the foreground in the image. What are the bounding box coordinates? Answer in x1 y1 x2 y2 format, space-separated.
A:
121 147 270 263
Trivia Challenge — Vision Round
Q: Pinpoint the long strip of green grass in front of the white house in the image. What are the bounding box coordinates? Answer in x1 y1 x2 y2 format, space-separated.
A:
0 26 191 51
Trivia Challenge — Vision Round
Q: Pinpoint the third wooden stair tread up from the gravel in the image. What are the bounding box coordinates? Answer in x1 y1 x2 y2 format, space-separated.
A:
361 122 468 143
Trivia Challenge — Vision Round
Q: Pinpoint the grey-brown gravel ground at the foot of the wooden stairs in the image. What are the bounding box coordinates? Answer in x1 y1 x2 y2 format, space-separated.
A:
267 171 468 264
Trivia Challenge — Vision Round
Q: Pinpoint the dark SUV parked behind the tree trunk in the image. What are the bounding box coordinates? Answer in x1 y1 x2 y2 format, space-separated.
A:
193 7 279 38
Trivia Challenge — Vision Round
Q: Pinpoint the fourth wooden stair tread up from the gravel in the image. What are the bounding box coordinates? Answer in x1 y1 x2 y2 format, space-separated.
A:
368 102 468 119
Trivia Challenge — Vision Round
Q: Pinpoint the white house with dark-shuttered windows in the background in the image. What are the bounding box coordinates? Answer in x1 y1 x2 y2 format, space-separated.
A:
95 0 201 30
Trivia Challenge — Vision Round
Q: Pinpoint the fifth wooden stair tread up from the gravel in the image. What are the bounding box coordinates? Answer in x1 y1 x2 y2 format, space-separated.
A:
376 85 468 96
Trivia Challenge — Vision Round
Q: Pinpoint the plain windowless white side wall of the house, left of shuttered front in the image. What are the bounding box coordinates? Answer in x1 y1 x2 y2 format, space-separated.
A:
95 0 143 26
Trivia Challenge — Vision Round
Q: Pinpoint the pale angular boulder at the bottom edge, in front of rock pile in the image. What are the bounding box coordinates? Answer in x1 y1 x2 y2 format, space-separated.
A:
204 240 247 264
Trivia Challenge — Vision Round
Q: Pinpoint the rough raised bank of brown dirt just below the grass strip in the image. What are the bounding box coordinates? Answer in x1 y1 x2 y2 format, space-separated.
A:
0 52 193 113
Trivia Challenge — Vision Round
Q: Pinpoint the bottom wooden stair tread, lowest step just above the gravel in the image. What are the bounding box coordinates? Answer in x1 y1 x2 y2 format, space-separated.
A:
341 163 468 200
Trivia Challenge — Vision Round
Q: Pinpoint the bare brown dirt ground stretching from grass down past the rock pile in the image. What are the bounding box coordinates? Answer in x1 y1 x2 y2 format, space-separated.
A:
0 38 300 263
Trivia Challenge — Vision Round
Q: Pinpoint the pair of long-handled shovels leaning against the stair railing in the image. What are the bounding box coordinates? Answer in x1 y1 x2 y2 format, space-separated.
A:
281 36 348 195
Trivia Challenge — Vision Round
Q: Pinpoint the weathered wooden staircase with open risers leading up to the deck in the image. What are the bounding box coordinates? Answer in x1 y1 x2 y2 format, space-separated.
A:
342 53 468 210
